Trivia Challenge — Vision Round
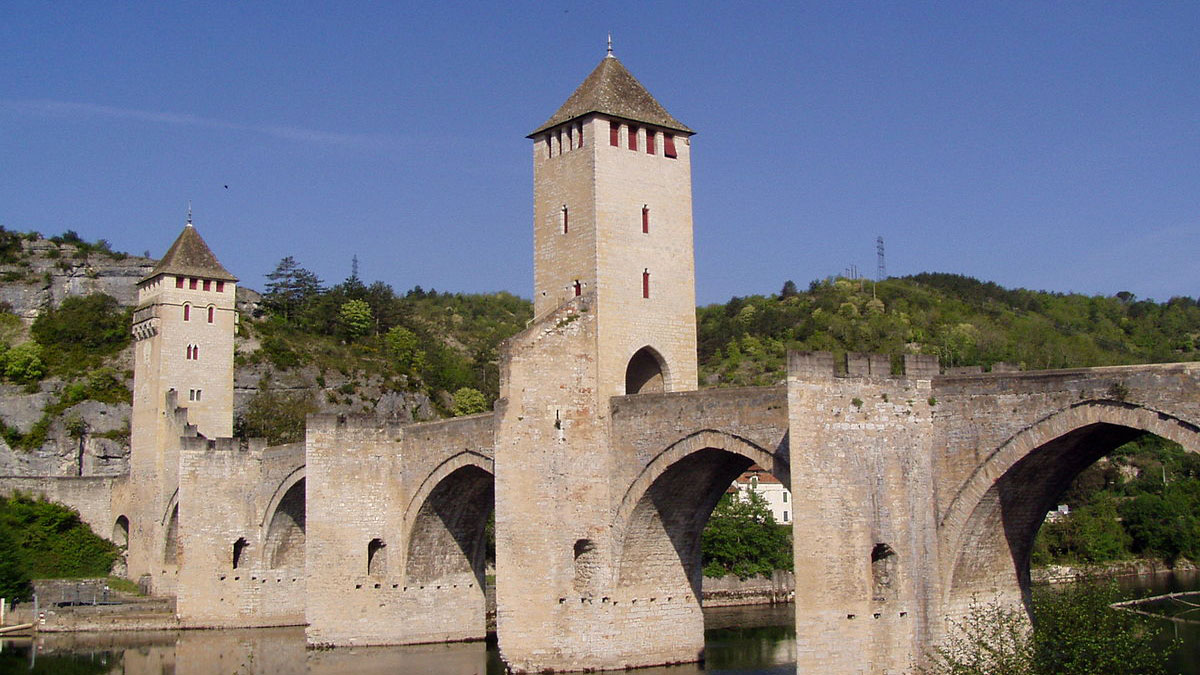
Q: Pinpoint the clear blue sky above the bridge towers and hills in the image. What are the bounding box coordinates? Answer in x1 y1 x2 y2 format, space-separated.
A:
0 0 1200 304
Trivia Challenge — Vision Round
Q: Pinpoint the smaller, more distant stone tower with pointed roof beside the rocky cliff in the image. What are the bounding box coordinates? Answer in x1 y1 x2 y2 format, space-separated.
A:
121 217 238 592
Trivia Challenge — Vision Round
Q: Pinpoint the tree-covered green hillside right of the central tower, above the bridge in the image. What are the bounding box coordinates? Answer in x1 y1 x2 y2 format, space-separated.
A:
697 274 1200 386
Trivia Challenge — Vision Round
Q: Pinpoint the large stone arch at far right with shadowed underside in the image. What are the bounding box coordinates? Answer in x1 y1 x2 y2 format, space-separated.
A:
938 400 1200 614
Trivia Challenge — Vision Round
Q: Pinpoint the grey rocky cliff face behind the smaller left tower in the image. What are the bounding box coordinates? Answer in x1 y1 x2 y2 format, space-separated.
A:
0 238 437 476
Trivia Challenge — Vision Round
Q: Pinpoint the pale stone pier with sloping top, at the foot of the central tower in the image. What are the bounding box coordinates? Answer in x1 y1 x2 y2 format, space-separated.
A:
496 293 648 671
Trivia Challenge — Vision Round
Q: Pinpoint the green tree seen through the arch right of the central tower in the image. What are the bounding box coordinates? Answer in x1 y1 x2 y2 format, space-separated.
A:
700 490 792 579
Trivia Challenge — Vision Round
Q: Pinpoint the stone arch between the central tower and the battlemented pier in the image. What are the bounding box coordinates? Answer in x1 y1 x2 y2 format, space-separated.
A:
614 430 791 595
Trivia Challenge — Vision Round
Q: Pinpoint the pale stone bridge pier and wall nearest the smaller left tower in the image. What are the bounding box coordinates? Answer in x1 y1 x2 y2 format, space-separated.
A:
176 437 305 627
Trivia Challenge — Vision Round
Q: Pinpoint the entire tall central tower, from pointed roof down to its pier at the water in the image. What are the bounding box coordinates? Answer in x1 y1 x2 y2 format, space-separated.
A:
496 49 703 673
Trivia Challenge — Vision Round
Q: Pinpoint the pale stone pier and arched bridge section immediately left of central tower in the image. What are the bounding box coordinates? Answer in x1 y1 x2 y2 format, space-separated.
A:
306 414 492 645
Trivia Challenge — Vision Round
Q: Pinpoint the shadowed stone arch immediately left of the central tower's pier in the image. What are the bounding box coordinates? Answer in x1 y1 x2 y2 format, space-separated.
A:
403 450 496 589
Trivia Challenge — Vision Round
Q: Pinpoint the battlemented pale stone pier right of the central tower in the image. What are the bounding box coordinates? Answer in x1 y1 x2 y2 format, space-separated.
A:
788 353 937 673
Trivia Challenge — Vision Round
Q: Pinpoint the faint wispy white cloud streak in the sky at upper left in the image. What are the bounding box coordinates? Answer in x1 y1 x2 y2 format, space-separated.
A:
0 98 391 148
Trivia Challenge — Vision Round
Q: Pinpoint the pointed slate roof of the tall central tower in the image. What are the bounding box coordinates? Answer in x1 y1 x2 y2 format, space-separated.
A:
527 54 695 138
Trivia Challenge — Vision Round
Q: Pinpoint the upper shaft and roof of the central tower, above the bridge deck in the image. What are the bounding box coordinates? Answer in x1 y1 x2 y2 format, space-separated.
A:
529 47 696 399
